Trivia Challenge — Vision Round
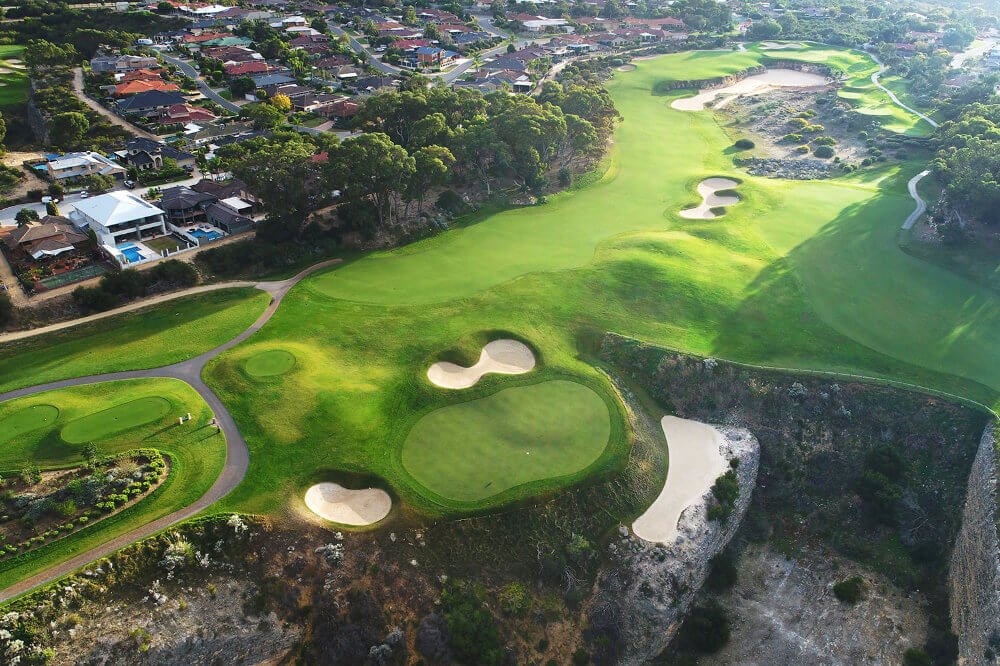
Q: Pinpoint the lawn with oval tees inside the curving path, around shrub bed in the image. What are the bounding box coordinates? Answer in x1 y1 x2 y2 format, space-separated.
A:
0 379 226 588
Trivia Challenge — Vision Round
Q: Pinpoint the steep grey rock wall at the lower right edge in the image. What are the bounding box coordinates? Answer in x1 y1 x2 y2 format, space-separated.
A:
949 423 1000 665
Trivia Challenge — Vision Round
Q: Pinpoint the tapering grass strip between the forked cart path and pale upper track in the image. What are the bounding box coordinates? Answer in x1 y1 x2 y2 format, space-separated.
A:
0 288 270 392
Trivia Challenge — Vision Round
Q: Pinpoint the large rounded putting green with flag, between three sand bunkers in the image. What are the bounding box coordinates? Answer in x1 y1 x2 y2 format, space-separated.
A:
402 380 611 502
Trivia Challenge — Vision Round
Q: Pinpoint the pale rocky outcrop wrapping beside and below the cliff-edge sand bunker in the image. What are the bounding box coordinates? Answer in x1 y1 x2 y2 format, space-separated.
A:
599 426 760 664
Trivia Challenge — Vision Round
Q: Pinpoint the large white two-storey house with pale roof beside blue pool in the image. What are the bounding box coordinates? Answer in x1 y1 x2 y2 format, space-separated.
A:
70 191 167 250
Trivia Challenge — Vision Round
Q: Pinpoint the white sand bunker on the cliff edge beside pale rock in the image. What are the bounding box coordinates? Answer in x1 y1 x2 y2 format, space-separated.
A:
632 416 728 543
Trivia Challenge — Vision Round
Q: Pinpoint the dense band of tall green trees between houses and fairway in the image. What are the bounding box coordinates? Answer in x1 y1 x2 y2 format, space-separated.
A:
219 77 619 241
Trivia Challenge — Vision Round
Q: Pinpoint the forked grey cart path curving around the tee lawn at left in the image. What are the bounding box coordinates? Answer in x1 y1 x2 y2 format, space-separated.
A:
0 259 341 602
